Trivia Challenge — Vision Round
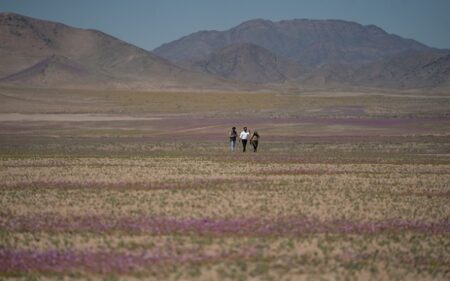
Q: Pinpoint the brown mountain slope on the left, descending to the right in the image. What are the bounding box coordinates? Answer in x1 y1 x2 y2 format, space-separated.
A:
0 13 229 88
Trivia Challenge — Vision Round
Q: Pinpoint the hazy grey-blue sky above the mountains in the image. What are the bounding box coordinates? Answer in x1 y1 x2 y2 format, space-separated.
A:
0 0 450 50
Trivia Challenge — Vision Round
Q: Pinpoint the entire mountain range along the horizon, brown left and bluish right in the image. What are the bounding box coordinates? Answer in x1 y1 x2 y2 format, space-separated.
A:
0 13 450 90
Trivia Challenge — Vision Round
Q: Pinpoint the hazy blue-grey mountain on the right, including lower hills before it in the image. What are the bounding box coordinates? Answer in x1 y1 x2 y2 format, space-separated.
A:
154 19 450 88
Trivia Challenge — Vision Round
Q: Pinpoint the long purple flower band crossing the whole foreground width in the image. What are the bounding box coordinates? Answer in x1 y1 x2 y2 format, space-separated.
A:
0 215 450 236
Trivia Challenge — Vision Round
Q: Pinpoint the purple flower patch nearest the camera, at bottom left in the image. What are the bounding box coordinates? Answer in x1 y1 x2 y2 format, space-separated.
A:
0 249 255 274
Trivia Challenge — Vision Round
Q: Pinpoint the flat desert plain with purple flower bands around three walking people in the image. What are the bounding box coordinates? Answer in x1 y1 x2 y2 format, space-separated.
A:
0 89 450 280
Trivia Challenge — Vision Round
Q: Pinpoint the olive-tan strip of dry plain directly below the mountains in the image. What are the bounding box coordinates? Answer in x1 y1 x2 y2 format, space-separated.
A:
0 87 450 118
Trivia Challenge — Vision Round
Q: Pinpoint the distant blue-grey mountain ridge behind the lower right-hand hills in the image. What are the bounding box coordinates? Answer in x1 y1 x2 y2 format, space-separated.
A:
154 19 432 66
